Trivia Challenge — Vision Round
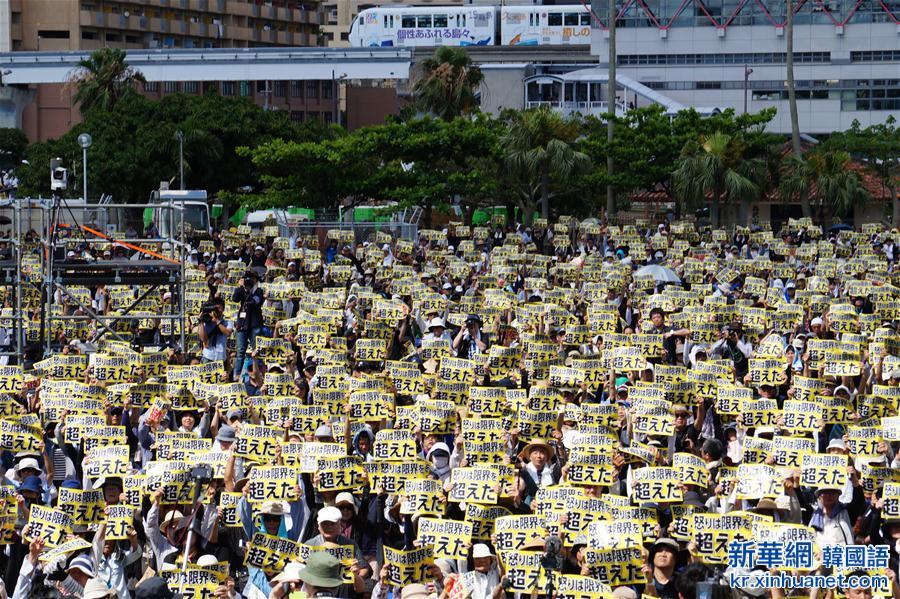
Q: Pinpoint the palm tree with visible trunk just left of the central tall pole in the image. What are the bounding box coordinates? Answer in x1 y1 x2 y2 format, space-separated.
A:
500 106 591 224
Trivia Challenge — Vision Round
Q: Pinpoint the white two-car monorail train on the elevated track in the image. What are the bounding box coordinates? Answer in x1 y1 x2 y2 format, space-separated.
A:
349 5 591 47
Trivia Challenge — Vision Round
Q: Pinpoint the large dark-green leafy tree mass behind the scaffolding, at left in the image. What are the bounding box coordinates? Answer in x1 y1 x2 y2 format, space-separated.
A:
17 94 326 202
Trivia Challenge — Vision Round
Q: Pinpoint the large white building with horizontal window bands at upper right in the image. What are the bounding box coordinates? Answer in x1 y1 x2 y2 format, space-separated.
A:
591 0 900 134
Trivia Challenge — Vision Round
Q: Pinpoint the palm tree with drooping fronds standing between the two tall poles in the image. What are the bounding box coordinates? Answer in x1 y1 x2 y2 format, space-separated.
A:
673 131 766 227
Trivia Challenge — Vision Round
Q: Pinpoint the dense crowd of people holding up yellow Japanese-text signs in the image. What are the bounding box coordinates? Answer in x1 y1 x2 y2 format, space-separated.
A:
0 217 900 599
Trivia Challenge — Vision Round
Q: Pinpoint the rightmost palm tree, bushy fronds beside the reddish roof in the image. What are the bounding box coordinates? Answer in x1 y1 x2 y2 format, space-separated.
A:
779 149 869 220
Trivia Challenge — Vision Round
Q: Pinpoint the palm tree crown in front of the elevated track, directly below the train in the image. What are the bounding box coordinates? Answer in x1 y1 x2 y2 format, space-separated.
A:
413 46 484 121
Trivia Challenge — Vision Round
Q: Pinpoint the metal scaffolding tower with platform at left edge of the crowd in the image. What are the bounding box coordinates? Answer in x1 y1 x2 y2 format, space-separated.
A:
0 197 187 364
